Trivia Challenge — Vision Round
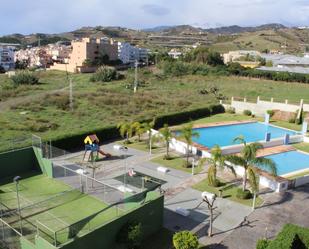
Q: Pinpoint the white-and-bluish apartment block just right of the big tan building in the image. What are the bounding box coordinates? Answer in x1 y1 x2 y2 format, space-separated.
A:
118 42 148 64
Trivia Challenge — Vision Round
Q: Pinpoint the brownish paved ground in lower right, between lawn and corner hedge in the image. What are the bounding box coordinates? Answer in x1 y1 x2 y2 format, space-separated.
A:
218 184 309 249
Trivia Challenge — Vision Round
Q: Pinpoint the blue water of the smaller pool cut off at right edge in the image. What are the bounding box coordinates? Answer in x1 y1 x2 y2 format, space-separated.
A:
266 151 309 175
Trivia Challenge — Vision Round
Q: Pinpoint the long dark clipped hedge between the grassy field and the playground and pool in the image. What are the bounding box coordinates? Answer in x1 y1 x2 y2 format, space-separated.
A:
52 105 225 150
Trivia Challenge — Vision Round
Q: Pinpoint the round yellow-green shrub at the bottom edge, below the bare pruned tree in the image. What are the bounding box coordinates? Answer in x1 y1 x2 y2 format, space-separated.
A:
173 231 199 249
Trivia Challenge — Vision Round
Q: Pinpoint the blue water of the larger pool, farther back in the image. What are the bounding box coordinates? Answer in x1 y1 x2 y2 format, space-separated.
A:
193 122 296 148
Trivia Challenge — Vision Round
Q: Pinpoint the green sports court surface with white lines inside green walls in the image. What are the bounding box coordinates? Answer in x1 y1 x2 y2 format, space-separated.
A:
0 175 119 245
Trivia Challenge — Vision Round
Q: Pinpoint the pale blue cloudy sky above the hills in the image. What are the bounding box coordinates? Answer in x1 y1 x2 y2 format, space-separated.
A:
0 0 309 35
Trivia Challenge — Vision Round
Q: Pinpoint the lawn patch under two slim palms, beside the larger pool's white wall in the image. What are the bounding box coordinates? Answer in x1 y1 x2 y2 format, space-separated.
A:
151 154 202 174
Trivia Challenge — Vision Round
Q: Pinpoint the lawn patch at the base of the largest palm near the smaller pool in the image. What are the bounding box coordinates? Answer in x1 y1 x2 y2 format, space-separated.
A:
192 179 263 206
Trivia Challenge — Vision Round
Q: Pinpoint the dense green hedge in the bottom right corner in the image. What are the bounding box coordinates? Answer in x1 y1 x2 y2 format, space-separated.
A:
267 224 309 249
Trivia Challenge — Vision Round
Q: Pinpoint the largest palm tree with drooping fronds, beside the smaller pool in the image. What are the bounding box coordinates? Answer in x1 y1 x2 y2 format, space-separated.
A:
226 136 277 192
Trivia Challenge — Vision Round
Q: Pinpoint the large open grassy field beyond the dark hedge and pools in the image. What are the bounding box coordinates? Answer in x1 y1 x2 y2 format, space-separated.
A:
0 70 309 151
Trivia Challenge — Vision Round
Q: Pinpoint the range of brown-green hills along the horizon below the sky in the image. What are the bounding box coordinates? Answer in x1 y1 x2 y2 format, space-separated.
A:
0 24 309 54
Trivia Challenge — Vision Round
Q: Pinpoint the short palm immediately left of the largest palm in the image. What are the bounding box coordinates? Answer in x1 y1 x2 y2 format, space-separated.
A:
200 145 236 187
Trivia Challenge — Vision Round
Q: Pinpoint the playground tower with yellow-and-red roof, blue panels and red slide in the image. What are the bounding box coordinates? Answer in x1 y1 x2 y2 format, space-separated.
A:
83 134 111 162
